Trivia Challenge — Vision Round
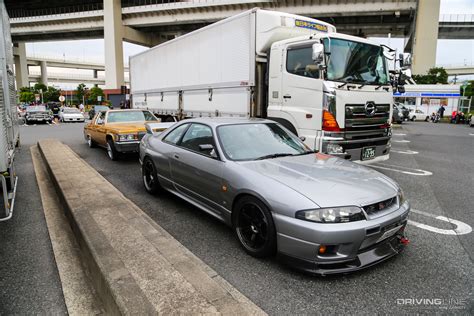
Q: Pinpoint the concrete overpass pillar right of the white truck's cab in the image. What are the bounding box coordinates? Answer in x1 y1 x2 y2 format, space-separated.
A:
412 0 440 75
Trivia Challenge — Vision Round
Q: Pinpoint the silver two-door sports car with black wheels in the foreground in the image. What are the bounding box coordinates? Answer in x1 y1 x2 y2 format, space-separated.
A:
140 118 410 274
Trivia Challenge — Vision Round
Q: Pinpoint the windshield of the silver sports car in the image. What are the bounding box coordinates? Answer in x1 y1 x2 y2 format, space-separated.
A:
217 123 313 160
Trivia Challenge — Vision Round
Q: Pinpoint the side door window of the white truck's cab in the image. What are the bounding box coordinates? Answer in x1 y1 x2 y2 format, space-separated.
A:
286 46 319 78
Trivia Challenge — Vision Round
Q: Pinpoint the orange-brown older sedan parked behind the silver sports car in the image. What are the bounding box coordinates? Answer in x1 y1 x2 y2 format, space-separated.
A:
84 110 159 160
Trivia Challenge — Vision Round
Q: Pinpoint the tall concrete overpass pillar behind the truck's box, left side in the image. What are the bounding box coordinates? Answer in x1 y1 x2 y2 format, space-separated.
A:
104 0 125 89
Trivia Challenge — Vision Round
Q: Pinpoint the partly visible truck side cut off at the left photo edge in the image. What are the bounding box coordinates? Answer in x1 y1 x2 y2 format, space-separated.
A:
0 0 19 221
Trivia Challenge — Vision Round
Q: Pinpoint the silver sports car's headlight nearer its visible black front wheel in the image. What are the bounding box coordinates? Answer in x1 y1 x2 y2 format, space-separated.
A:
296 206 365 223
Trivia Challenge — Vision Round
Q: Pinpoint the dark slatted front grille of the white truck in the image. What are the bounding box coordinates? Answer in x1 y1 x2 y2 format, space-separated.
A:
345 103 390 131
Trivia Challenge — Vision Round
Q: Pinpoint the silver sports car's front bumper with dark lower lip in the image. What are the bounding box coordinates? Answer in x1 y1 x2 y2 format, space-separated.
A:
274 203 410 275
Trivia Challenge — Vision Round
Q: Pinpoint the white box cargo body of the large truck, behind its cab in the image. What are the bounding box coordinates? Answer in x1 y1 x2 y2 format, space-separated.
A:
129 9 335 117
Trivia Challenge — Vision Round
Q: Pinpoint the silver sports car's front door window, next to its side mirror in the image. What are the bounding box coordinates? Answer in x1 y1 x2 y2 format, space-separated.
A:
179 124 215 156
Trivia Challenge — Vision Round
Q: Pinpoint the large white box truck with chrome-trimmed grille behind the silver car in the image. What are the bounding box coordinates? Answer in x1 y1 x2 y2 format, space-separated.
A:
130 8 401 162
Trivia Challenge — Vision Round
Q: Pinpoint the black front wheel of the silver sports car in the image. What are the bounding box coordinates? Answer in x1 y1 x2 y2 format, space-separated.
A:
233 196 276 258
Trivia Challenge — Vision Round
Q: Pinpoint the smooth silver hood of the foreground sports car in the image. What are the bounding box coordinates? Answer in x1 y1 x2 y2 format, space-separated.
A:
240 153 398 207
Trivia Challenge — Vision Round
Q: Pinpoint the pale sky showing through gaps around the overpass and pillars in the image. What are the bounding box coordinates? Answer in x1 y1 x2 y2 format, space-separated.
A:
26 0 474 89
